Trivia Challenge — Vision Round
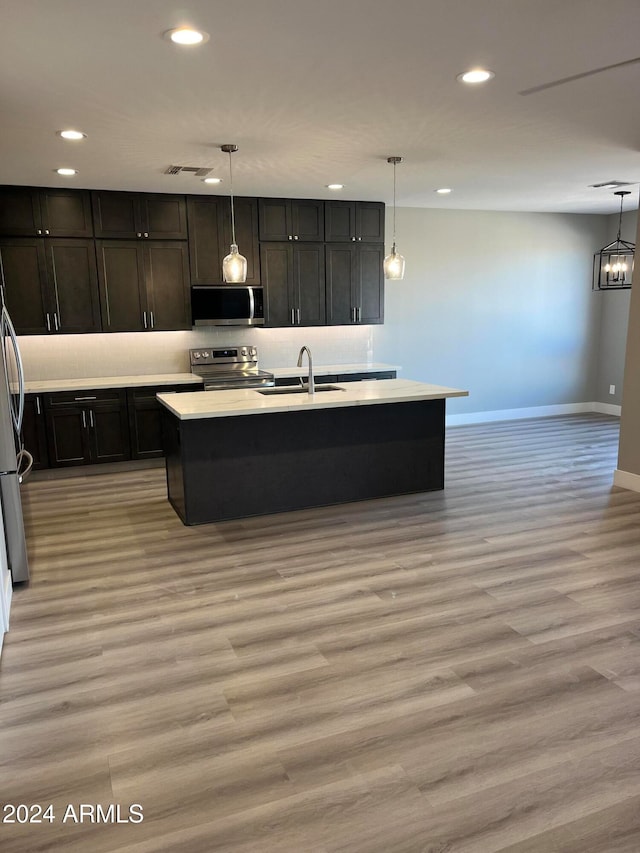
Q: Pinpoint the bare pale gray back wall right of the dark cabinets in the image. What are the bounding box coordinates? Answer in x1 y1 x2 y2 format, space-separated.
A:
374 208 613 414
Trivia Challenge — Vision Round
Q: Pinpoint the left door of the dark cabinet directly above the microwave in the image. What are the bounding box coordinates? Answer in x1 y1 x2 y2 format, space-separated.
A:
187 196 228 284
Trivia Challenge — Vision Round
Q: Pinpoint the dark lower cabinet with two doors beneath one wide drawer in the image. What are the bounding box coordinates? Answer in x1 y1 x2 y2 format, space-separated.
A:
45 389 131 467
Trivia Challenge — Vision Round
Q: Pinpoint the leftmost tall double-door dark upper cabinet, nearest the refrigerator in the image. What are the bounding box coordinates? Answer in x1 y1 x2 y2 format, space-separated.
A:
0 237 101 335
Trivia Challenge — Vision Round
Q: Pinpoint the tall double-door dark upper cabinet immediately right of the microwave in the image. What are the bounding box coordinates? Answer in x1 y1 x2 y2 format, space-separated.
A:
260 242 325 327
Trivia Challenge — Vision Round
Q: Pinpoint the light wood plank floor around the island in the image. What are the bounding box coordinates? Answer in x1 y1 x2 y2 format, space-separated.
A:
0 415 640 853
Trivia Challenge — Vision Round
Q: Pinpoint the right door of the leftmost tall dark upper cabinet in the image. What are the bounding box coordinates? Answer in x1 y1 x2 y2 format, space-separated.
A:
44 238 102 334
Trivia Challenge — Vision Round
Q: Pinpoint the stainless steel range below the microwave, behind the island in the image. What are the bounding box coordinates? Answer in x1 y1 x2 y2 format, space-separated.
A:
189 346 275 391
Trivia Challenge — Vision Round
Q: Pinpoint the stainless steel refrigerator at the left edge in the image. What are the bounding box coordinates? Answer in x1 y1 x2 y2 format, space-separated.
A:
0 299 33 583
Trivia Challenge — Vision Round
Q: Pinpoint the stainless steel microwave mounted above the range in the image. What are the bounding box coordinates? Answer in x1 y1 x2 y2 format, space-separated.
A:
191 284 264 326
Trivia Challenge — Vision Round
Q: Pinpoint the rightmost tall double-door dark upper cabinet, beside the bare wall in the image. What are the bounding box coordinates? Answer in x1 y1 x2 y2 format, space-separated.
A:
325 243 384 326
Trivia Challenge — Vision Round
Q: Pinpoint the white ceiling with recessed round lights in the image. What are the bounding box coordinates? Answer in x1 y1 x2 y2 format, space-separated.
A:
0 0 640 213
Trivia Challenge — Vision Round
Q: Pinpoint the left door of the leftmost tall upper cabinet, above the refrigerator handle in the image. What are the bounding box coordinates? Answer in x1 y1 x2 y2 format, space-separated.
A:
0 237 48 335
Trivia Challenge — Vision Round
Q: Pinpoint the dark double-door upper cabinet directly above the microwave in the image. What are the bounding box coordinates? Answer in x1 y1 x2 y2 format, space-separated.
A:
187 196 260 285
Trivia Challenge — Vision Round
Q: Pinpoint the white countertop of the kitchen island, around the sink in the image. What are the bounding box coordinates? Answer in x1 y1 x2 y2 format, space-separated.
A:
158 374 469 420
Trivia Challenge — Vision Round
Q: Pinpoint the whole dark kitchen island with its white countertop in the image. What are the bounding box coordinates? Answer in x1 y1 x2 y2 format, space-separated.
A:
158 379 468 525
